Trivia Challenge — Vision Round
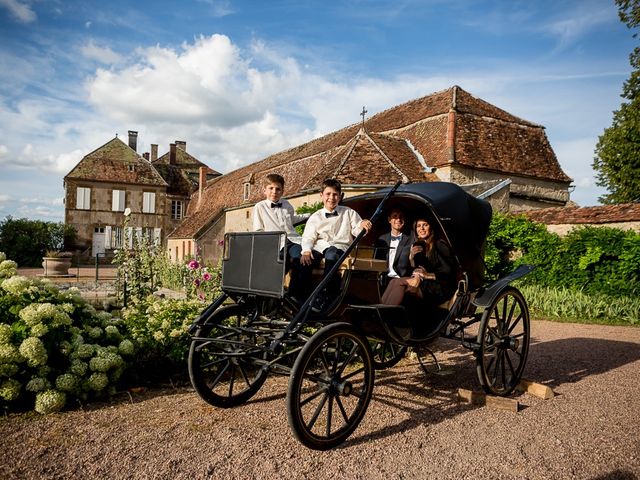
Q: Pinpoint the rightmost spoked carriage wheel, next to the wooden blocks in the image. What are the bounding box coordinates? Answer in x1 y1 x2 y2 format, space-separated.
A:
476 287 529 396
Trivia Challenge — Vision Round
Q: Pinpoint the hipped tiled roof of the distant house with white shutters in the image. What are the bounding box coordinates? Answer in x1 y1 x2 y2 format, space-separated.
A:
65 137 167 187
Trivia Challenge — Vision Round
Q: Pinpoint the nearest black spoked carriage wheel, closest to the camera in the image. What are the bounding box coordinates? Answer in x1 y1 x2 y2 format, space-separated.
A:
287 323 375 450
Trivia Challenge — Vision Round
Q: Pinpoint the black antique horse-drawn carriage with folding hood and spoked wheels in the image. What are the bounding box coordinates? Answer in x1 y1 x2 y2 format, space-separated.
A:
189 182 532 450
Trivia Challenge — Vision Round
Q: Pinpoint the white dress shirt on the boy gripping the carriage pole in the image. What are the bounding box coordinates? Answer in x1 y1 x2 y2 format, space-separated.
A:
302 205 362 252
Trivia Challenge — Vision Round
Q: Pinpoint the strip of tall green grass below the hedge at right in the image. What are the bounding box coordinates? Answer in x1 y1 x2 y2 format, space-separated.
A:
518 285 640 325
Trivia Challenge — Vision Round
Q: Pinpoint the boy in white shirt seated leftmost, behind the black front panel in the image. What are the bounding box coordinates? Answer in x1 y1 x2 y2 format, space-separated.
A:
253 173 309 299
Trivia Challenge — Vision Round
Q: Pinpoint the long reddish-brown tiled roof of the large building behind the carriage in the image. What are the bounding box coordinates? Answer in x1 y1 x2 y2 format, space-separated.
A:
171 86 571 238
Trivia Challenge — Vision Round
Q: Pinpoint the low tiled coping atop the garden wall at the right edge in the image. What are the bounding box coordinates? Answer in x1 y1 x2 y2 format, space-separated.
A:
523 203 640 225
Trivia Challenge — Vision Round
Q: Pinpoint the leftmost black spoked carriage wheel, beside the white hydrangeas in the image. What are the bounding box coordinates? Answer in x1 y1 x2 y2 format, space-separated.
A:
189 305 268 408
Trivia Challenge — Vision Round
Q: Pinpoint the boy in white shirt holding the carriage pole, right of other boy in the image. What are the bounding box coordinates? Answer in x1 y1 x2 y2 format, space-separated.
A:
300 178 371 311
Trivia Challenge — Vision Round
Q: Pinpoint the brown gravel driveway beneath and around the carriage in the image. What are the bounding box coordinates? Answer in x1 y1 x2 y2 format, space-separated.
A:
0 321 640 480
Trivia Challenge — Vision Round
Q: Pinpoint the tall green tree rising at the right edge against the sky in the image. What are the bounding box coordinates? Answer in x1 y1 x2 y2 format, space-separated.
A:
593 0 640 204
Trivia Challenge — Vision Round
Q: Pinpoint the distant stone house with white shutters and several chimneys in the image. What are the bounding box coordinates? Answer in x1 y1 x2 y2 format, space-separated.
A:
64 131 219 257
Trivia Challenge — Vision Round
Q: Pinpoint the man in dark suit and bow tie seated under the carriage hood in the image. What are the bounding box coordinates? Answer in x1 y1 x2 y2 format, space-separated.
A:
374 208 413 291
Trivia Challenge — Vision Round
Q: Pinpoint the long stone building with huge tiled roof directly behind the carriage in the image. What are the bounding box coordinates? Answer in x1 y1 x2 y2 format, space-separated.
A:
167 86 571 266
